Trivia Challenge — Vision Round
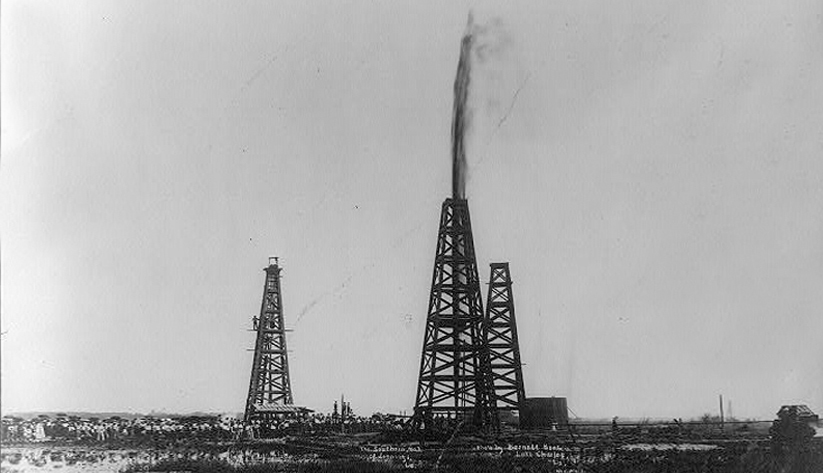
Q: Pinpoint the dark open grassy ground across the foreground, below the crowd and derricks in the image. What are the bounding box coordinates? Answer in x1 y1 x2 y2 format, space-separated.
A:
2 426 823 473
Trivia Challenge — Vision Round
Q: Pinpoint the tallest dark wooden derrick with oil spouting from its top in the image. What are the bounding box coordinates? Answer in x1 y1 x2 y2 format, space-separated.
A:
414 198 496 426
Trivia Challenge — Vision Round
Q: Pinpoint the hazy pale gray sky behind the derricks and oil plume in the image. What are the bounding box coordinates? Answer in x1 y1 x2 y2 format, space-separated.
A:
0 0 823 417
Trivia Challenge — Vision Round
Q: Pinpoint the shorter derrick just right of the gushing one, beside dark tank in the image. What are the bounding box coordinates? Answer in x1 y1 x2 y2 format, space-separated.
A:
485 263 526 411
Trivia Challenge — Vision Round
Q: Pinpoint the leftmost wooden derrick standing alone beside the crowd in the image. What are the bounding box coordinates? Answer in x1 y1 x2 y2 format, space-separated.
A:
244 258 293 422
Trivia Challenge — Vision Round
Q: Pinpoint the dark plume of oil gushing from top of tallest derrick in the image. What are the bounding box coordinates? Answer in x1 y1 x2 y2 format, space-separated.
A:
451 13 474 199
